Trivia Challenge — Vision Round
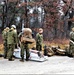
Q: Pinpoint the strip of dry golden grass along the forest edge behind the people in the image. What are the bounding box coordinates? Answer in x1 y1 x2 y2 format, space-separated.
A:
0 40 69 53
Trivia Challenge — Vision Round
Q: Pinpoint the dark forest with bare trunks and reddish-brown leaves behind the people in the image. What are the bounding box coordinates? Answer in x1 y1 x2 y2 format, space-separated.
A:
0 0 74 41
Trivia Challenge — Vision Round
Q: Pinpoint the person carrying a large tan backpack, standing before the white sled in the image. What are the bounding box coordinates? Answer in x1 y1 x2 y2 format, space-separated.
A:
20 28 35 62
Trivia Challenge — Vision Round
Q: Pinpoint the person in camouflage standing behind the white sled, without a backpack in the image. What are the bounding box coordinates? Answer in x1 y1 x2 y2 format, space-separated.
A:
36 28 43 51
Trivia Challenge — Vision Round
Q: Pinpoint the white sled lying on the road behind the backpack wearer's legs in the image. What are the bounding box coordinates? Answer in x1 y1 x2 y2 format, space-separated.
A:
13 48 48 62
